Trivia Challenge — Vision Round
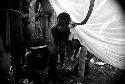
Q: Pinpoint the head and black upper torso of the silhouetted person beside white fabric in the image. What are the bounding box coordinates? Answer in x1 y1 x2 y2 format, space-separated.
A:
52 12 71 43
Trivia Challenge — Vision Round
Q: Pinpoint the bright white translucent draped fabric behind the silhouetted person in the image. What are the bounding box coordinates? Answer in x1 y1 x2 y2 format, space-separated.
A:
49 0 125 69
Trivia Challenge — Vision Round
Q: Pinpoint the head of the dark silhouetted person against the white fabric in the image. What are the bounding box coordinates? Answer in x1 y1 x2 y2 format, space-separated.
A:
57 12 71 26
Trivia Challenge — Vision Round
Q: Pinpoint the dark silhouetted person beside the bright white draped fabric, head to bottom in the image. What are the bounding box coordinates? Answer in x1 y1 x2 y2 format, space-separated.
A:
51 12 85 84
